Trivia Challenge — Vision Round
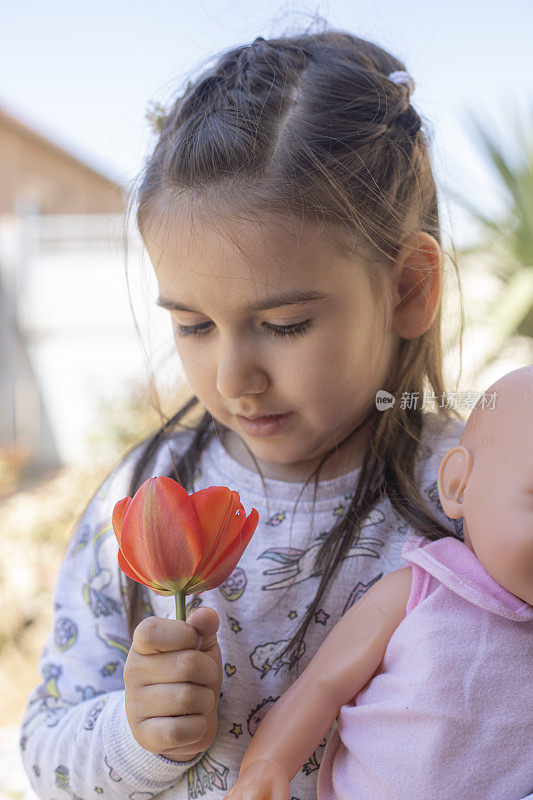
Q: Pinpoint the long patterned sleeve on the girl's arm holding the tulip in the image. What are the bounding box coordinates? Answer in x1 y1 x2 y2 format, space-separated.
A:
20 446 203 800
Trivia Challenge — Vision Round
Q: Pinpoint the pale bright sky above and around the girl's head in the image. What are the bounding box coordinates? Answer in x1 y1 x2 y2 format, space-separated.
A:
0 0 533 245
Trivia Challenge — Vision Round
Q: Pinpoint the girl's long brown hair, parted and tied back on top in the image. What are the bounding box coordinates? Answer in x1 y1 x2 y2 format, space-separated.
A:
119 23 462 680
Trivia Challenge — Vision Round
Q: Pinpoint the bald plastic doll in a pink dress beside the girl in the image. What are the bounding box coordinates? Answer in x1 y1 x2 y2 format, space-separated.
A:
221 365 533 800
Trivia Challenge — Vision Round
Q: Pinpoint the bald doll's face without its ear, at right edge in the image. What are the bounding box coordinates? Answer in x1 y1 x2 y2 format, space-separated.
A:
462 381 533 605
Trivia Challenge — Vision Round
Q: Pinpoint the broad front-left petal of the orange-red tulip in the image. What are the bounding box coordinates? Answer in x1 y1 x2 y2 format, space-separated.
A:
121 476 203 586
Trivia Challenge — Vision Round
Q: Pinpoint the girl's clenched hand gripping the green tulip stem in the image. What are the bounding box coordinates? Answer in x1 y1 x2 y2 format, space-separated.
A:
124 607 222 761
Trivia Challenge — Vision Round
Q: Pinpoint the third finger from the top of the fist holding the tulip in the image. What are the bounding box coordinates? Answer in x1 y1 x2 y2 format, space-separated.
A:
133 683 217 720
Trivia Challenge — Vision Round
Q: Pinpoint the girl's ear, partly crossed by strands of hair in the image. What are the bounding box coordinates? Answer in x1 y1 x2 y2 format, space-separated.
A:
392 231 442 339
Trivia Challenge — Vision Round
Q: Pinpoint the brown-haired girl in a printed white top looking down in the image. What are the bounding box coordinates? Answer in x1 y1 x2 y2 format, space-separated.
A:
20 25 463 800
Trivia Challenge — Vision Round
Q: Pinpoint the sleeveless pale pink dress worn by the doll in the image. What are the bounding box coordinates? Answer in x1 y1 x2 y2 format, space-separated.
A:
318 536 533 800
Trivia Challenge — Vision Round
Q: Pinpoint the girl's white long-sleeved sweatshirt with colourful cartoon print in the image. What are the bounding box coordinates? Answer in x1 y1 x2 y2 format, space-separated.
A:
20 412 463 800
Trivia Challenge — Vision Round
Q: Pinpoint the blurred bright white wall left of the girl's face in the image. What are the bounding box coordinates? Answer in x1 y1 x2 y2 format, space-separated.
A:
0 215 181 463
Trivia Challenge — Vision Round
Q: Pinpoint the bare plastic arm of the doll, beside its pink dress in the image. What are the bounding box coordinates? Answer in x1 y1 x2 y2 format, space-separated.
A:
228 567 411 800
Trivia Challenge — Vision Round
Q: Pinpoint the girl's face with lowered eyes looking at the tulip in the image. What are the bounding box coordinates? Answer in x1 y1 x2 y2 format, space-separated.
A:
146 208 398 481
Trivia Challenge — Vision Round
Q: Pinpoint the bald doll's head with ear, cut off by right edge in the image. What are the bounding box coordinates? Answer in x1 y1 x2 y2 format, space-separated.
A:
437 364 533 605
